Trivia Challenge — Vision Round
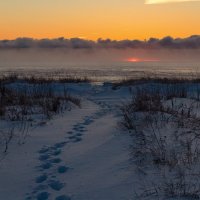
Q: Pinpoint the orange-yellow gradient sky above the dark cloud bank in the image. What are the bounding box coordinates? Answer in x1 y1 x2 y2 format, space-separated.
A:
0 0 200 40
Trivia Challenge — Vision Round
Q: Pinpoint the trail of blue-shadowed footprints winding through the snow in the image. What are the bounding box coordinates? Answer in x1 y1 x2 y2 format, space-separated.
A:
25 106 109 200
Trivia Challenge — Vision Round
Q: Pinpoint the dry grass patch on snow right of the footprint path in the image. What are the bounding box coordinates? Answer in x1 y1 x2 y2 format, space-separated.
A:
121 83 200 199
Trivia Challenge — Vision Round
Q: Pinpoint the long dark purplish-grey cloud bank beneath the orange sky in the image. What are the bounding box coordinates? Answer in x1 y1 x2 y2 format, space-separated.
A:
0 35 200 49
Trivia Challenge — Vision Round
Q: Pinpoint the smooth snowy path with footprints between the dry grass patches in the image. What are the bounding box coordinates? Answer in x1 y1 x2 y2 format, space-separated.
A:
0 88 134 200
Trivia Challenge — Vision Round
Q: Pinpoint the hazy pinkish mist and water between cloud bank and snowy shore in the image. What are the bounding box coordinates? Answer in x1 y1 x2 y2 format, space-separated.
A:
0 49 200 80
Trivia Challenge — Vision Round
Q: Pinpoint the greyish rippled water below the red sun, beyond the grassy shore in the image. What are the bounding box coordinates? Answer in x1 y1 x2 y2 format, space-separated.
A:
0 62 200 81
